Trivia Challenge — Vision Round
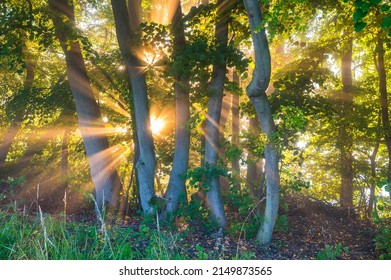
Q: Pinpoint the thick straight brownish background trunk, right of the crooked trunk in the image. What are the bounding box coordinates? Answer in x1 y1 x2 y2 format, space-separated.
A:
339 39 353 209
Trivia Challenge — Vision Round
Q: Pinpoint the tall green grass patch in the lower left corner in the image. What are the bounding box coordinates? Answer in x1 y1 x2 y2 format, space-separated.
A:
0 203 190 260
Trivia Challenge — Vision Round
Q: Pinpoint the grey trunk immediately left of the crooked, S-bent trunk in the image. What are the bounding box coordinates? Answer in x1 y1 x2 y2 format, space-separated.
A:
205 1 228 227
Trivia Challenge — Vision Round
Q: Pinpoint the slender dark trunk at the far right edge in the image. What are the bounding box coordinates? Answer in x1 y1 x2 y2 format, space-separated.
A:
375 33 391 198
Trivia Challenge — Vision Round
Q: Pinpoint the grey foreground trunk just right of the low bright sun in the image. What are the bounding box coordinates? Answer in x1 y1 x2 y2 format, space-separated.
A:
165 1 190 213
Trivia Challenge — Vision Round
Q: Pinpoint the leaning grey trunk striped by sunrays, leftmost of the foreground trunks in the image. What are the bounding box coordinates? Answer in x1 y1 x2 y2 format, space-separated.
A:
48 0 121 210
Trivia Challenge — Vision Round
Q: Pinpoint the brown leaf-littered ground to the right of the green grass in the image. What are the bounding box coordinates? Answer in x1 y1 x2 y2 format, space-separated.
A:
114 195 381 260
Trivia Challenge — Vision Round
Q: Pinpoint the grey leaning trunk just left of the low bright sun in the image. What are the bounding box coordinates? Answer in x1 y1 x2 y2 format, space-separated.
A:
111 0 156 214
